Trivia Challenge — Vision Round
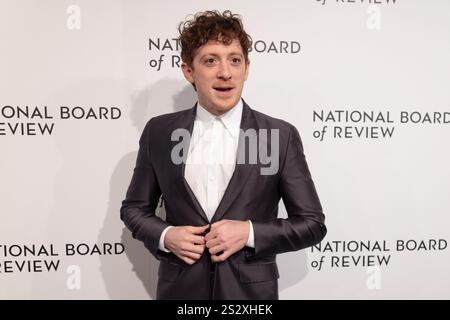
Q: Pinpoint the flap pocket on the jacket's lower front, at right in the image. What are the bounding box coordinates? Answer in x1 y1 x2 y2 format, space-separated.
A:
238 262 280 283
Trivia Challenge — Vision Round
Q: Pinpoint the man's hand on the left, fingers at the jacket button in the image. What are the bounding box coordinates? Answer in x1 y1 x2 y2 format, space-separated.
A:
164 224 209 265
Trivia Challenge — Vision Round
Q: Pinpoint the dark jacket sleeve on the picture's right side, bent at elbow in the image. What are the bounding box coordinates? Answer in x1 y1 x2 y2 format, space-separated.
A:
249 126 327 257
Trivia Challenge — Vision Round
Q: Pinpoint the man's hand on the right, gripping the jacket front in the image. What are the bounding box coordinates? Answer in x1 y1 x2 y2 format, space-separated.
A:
205 220 250 262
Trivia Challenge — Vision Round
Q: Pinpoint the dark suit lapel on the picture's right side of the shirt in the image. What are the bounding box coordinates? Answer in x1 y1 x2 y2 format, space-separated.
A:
211 99 258 223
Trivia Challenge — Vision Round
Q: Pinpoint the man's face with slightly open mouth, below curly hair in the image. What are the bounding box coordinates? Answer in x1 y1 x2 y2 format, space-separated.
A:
181 39 249 115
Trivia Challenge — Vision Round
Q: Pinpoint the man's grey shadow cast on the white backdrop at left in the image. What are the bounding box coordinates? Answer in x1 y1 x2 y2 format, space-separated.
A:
99 79 196 299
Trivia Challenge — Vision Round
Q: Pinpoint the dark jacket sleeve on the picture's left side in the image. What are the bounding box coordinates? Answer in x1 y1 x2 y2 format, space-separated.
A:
120 120 169 259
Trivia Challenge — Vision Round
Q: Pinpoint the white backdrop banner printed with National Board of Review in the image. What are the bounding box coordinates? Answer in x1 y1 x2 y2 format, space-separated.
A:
0 0 450 299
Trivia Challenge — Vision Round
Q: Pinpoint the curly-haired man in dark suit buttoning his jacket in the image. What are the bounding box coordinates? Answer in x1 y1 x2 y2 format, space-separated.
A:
121 11 326 299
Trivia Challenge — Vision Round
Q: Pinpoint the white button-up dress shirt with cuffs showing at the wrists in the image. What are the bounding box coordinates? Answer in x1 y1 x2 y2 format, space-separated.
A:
159 99 254 252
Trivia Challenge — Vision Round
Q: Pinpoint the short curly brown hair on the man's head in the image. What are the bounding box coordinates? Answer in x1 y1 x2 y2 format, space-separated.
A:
178 10 252 67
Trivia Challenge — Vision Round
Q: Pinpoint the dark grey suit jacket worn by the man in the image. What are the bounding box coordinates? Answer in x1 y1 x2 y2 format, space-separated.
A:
120 101 326 299
